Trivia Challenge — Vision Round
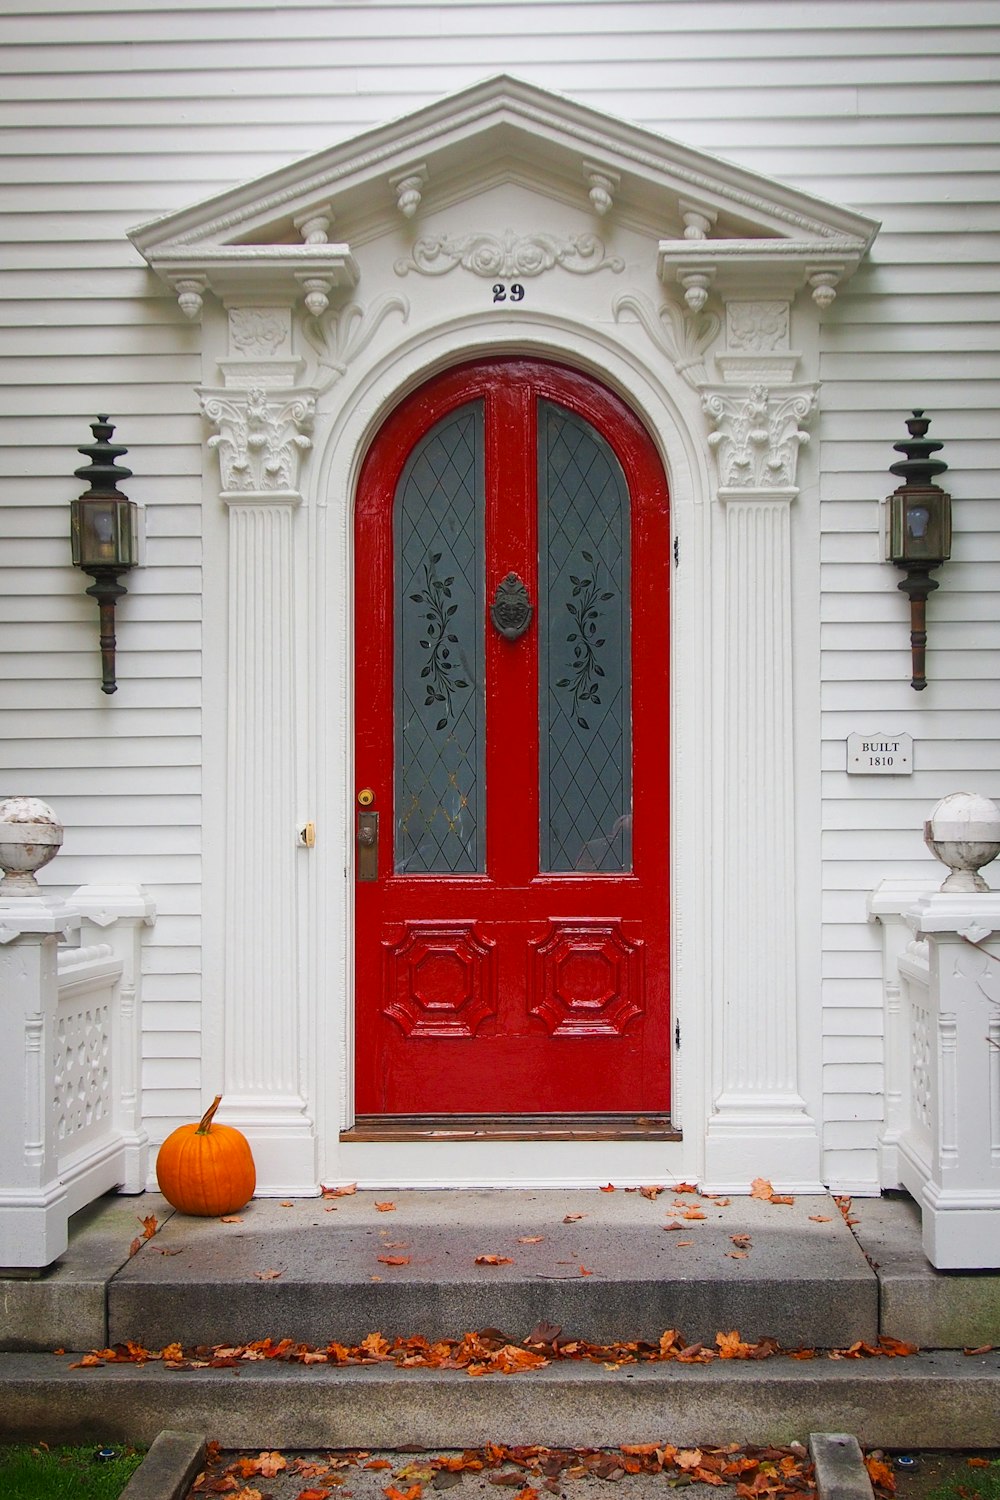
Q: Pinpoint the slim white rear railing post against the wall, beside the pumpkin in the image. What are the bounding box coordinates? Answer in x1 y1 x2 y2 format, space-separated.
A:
67 885 156 1193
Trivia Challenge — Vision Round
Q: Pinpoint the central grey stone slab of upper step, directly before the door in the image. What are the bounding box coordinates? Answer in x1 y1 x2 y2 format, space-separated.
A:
106 1191 879 1349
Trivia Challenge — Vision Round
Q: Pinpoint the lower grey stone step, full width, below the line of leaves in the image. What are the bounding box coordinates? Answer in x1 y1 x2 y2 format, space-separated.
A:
0 1352 1000 1449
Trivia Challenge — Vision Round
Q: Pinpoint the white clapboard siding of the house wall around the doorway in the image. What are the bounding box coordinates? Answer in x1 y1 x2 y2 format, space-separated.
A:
0 0 1000 1164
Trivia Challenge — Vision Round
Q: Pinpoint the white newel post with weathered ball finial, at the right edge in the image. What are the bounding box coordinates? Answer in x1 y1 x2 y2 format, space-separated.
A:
898 792 1000 1271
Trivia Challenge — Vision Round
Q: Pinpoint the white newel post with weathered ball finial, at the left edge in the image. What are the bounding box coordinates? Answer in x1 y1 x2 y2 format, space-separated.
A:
0 797 79 1269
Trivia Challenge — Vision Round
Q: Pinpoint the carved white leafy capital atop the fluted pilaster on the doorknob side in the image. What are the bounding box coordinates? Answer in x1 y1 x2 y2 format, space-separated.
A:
201 386 316 500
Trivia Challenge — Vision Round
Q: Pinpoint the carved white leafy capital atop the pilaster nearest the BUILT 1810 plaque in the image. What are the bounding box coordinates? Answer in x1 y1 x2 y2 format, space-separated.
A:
702 386 816 491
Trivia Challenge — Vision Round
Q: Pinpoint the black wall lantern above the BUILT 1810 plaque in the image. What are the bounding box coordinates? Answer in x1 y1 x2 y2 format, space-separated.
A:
889 411 952 693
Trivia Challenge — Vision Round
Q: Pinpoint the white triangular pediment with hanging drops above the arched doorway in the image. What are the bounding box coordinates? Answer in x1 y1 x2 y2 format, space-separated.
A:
130 77 879 313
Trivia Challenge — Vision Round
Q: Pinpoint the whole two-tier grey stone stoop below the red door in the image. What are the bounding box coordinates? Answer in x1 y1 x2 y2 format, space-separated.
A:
0 1191 1000 1448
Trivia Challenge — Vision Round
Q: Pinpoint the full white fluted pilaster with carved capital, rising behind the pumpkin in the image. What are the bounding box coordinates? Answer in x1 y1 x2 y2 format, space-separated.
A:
202 316 318 1196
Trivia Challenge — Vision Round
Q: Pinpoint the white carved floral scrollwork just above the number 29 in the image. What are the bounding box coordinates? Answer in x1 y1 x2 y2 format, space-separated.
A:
396 230 625 281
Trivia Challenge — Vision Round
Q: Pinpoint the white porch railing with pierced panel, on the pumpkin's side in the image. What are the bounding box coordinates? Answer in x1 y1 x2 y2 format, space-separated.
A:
0 887 154 1269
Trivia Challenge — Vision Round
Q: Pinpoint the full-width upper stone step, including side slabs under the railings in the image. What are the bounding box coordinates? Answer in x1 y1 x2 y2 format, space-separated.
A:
0 1191 1000 1352
